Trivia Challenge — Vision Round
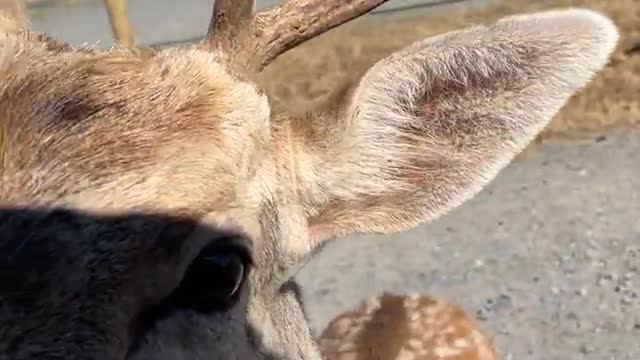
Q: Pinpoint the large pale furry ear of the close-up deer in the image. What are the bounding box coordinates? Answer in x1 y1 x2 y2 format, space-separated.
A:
296 9 618 242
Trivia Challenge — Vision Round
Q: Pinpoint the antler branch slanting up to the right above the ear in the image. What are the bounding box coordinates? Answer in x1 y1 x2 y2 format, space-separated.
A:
251 0 388 71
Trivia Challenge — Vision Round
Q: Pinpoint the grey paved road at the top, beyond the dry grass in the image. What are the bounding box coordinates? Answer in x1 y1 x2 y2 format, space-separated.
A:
27 0 488 47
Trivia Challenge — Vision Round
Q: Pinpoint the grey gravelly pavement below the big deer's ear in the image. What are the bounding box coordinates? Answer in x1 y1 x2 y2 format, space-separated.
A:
299 130 640 360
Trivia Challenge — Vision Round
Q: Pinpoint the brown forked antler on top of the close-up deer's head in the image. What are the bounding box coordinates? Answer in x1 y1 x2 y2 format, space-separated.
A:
205 0 388 71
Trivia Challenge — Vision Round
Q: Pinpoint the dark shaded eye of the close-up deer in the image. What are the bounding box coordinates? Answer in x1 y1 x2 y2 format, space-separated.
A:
172 245 250 313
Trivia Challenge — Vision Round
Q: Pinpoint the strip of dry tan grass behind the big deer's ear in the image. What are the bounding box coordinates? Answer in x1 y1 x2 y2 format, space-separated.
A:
262 0 640 136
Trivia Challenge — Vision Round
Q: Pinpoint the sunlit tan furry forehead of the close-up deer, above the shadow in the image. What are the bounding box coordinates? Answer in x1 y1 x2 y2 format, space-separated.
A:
0 35 270 211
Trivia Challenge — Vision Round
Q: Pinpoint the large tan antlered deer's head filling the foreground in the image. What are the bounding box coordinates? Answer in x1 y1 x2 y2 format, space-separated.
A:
0 0 618 360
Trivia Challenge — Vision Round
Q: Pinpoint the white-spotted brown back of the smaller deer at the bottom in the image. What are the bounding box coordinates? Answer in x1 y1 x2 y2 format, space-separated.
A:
318 293 498 360
